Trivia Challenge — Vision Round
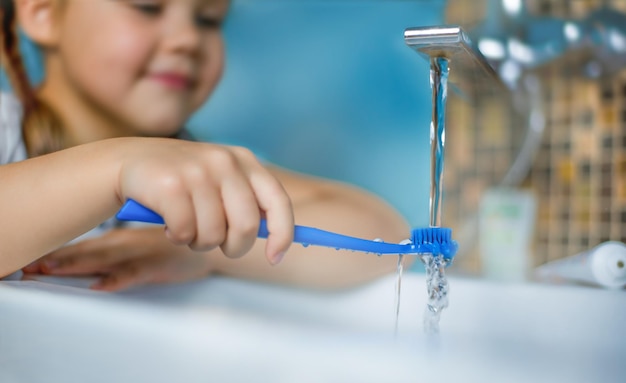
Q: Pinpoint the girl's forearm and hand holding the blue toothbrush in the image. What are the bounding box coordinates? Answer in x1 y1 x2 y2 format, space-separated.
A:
0 138 293 276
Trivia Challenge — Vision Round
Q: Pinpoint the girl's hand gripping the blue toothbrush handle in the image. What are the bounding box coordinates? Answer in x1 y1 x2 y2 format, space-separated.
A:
118 139 294 264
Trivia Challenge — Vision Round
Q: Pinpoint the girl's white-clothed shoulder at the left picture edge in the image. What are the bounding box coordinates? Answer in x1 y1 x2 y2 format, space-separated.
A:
0 92 26 164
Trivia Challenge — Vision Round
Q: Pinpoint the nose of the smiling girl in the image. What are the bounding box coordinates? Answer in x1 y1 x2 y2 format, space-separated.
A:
164 10 201 55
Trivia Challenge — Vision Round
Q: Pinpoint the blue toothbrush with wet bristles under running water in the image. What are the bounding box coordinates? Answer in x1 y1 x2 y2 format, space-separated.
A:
116 199 458 260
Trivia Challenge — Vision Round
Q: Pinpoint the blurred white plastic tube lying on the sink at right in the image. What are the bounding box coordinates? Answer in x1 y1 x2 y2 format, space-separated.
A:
535 241 626 289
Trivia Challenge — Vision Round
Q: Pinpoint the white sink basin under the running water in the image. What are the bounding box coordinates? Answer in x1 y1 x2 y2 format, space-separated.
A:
0 274 626 383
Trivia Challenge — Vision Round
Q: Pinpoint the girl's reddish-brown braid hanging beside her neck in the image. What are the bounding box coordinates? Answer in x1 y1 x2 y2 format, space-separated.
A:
0 0 66 157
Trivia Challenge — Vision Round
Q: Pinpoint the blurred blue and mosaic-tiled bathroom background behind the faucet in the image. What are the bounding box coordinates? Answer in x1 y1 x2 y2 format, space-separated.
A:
0 0 626 279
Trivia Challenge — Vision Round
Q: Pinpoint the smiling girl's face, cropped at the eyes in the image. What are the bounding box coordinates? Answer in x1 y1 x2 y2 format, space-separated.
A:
52 0 228 136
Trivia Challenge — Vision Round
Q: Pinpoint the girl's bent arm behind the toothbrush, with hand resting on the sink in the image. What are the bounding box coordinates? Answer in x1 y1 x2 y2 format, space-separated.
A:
26 165 412 290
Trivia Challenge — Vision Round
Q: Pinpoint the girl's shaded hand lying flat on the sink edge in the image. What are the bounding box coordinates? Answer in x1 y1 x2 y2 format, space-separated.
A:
23 227 213 291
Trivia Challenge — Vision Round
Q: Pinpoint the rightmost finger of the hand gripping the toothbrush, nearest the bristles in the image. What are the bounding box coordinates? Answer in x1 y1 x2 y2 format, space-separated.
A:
244 164 294 265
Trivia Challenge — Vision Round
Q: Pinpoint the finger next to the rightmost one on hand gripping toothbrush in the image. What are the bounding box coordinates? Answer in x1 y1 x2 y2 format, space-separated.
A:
221 175 261 258
